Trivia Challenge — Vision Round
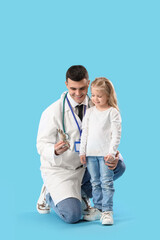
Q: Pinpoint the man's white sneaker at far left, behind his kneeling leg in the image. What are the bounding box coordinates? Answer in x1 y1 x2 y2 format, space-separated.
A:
37 184 51 214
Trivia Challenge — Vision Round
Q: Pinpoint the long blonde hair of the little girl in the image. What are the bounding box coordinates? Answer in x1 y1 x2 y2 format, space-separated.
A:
91 77 119 111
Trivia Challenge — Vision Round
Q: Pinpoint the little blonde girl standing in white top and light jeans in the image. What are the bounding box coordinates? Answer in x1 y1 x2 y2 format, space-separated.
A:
80 77 121 225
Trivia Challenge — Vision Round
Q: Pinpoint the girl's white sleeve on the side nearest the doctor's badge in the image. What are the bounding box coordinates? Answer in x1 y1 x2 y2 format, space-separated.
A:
79 111 89 155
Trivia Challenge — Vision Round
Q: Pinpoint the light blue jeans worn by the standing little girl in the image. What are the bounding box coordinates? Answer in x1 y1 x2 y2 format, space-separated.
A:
87 156 114 212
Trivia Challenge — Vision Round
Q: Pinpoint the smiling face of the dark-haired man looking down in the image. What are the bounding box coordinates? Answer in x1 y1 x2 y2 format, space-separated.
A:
65 78 90 104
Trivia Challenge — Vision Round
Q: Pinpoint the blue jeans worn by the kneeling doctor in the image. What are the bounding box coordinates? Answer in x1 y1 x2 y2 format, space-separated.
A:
46 155 126 223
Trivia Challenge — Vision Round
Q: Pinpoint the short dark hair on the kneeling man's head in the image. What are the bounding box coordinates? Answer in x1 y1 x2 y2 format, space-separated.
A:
66 65 89 82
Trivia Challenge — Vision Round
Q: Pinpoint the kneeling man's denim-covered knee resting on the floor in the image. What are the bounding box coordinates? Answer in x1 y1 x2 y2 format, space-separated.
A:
57 198 82 223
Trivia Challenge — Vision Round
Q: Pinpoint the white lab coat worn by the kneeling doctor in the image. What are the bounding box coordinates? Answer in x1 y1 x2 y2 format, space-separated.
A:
37 93 91 204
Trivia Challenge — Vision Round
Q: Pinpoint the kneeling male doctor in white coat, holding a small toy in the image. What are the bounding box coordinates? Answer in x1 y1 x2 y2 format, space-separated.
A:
37 65 125 223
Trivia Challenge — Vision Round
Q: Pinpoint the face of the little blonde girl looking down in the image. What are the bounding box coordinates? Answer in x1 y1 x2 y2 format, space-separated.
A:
91 87 108 110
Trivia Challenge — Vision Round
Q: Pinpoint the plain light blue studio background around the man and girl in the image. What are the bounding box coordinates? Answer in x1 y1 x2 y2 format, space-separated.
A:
0 0 160 240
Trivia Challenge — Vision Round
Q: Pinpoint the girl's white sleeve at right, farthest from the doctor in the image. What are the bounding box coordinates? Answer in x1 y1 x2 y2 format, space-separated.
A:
109 108 122 157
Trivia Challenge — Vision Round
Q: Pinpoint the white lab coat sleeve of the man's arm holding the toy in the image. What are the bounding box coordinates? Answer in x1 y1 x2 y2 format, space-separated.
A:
37 112 58 163
